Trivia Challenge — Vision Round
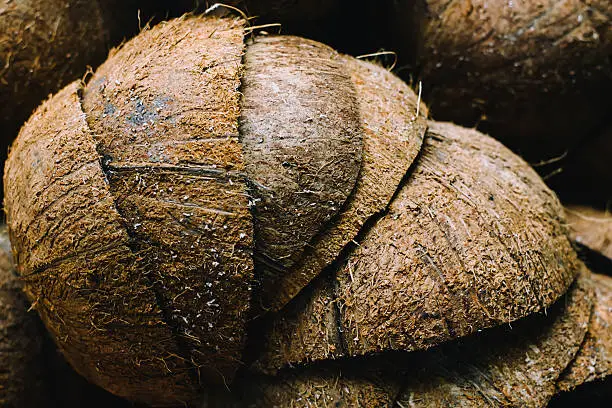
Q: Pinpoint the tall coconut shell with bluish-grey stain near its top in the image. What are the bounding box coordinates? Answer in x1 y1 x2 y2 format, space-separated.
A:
83 17 253 392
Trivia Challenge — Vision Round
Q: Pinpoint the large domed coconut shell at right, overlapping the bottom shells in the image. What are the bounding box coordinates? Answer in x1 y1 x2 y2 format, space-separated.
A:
259 122 578 368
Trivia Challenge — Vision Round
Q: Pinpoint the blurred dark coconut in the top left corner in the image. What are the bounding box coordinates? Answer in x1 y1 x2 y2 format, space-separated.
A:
0 0 107 143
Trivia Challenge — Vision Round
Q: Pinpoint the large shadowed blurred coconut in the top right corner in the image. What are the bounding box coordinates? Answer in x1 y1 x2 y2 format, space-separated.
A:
389 0 612 161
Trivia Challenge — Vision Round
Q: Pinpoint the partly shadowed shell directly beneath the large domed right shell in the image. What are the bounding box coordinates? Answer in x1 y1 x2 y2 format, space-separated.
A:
398 271 593 408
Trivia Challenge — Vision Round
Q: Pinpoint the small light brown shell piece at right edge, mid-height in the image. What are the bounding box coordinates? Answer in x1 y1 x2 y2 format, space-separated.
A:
565 205 612 258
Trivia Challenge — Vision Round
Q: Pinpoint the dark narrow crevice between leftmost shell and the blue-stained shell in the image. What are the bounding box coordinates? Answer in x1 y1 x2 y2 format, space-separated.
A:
78 88 200 392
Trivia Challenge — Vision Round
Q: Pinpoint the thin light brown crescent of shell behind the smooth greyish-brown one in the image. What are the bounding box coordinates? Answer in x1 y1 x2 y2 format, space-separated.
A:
245 50 427 310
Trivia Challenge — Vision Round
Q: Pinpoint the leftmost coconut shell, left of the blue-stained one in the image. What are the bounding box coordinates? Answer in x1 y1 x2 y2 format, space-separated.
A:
4 82 195 405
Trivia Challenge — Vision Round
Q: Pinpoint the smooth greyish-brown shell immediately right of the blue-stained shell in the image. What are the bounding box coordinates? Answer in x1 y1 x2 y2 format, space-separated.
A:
240 36 363 308
